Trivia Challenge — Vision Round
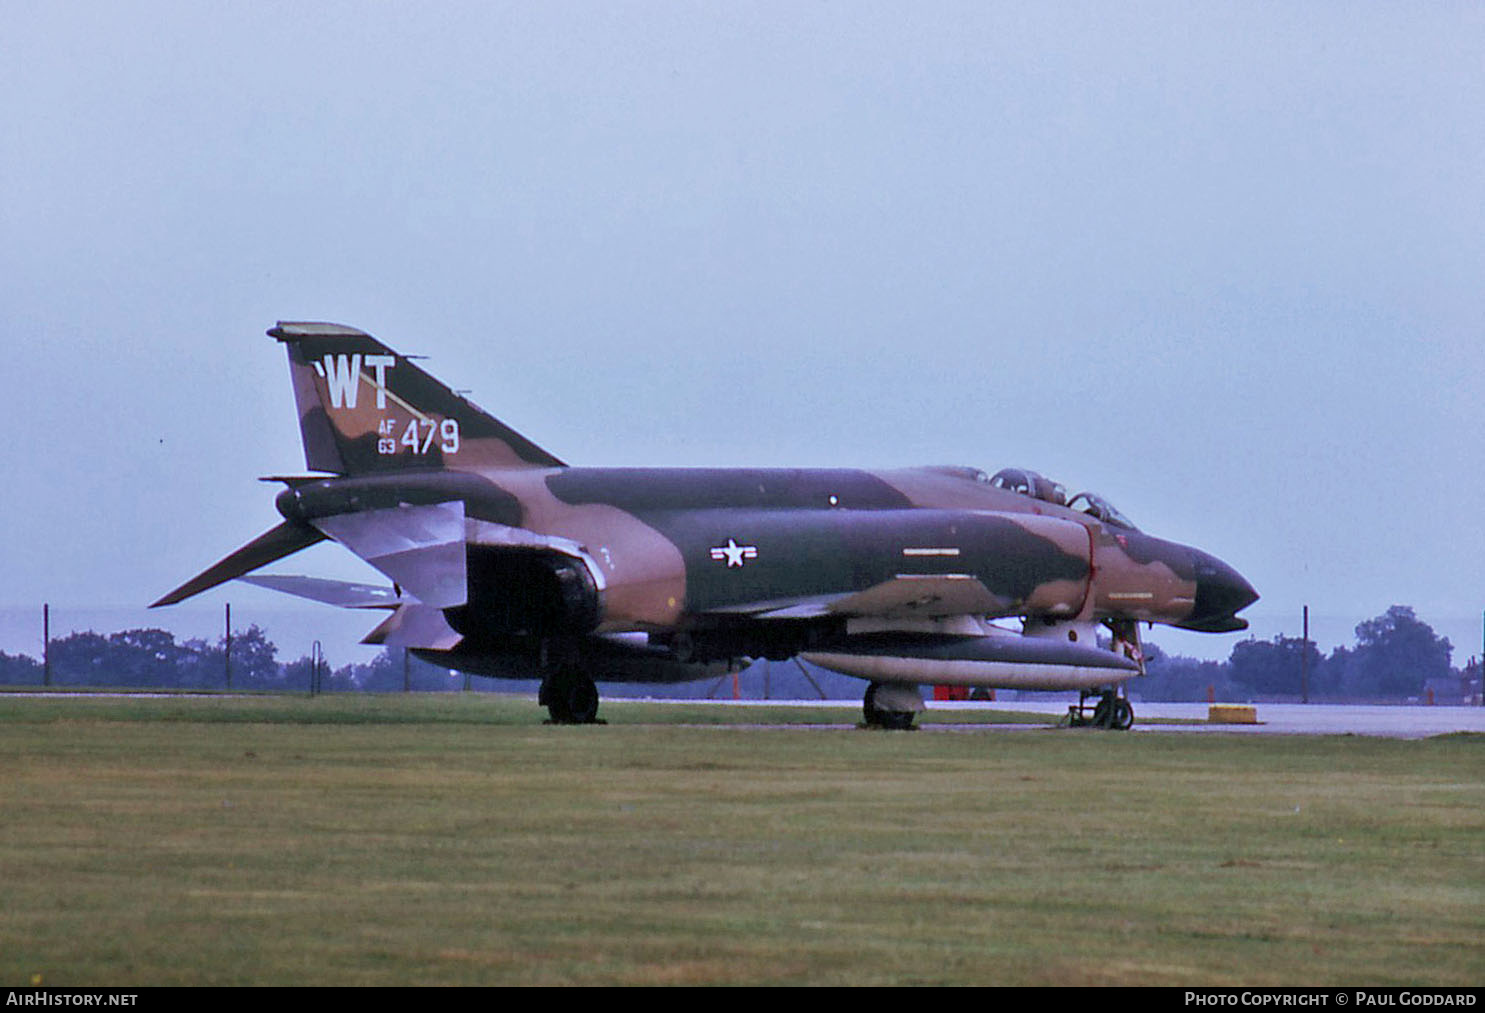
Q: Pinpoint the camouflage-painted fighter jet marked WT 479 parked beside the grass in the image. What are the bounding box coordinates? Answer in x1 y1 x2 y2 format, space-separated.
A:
154 322 1258 728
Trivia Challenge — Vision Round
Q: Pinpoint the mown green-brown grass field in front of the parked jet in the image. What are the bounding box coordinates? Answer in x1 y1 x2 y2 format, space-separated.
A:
0 694 1485 986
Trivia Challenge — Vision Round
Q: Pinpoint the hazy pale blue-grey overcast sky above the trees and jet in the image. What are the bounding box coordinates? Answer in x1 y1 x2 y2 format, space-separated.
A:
0 3 1485 661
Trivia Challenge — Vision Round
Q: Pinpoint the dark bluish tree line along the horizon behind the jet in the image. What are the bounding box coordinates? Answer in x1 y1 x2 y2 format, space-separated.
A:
0 605 1479 703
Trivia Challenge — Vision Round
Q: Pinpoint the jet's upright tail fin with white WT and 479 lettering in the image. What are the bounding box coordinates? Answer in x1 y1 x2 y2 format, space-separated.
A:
269 321 563 475
